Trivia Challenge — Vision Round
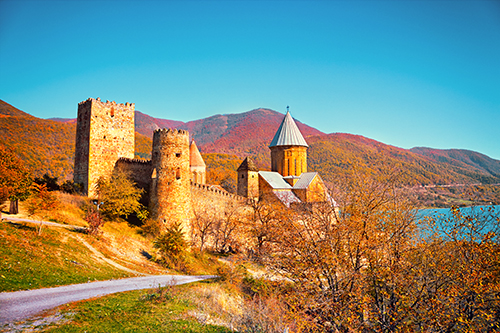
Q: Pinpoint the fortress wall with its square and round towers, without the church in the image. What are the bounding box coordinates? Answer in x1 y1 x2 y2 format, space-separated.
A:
74 98 247 232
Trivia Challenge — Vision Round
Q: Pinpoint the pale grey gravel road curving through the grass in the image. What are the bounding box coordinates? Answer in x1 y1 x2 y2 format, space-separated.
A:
0 275 215 326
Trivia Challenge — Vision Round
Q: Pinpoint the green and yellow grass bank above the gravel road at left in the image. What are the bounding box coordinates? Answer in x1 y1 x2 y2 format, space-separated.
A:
0 222 133 292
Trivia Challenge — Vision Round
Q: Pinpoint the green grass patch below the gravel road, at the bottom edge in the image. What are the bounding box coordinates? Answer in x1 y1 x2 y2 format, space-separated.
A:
44 286 232 333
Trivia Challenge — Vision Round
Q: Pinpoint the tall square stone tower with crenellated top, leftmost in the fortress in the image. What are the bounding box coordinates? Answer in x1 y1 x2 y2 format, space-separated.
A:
73 98 135 197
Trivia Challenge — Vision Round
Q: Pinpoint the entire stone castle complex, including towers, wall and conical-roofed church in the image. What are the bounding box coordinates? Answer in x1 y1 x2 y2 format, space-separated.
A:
74 98 328 225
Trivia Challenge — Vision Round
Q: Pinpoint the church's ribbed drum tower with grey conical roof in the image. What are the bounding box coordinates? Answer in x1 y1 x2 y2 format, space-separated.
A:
269 111 309 177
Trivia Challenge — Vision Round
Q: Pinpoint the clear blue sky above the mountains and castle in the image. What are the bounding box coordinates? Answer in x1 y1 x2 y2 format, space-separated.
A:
0 0 500 160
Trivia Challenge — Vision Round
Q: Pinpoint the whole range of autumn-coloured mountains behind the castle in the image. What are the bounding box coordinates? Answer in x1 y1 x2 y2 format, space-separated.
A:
0 101 500 192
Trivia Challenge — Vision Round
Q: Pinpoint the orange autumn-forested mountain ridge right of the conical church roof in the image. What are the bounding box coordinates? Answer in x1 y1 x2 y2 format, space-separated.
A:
308 133 500 185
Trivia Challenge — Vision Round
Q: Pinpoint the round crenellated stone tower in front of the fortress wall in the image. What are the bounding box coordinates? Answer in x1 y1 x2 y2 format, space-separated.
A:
149 129 193 228
